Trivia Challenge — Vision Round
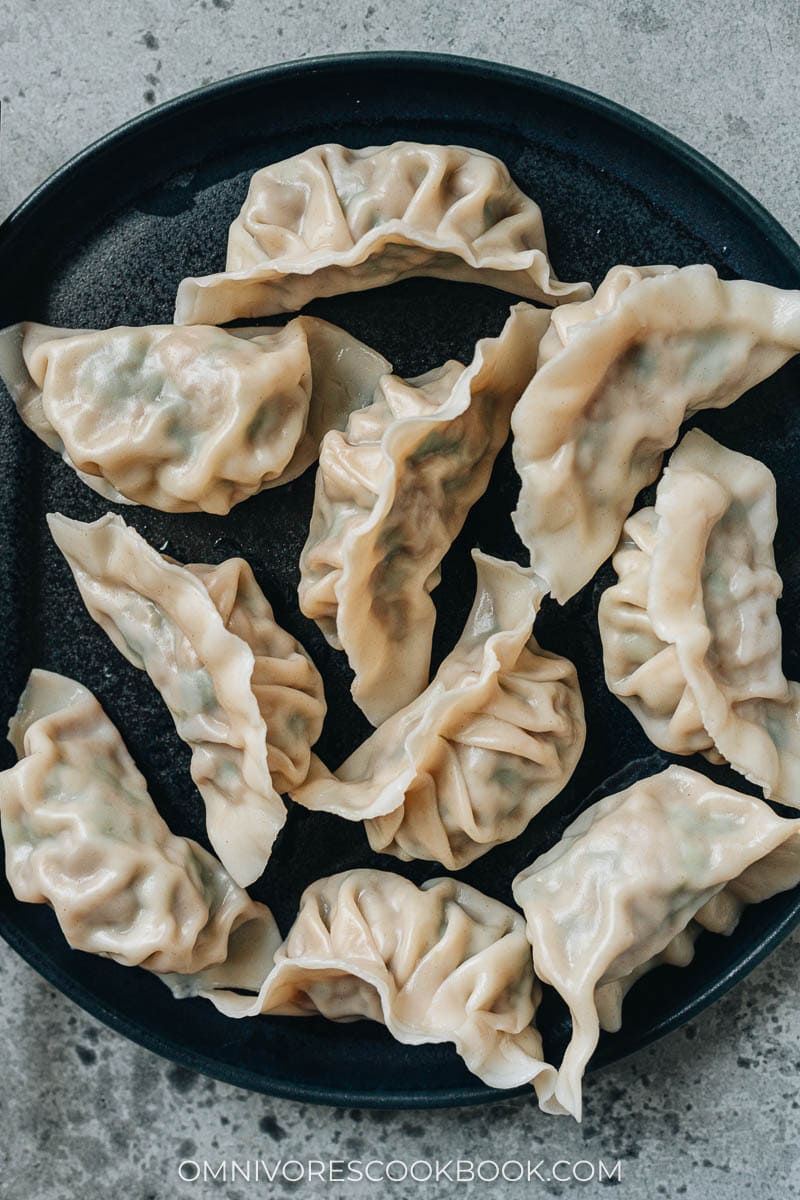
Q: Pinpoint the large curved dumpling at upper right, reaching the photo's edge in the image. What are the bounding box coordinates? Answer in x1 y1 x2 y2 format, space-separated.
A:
511 265 800 601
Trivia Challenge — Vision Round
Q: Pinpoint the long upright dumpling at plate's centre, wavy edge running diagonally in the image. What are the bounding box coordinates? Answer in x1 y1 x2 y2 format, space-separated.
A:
299 305 548 725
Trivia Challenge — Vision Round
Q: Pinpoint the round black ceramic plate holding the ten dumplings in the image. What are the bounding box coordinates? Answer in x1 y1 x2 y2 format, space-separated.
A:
0 54 800 1106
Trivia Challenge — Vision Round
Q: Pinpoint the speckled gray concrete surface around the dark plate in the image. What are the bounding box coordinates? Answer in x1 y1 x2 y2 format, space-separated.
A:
0 0 800 1200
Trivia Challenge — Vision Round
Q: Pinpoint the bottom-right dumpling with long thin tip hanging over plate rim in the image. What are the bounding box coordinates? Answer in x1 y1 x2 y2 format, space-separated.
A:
513 767 800 1120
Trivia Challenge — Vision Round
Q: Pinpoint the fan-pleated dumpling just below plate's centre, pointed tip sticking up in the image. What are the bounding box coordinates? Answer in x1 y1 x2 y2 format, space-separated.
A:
291 551 585 870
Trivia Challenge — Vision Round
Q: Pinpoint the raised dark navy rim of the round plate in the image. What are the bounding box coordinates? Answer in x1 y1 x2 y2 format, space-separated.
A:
0 50 800 1110
